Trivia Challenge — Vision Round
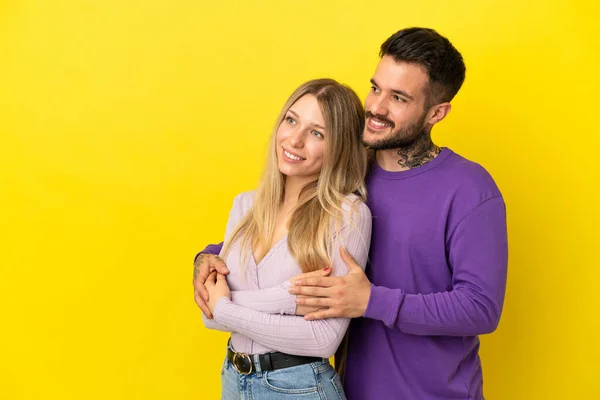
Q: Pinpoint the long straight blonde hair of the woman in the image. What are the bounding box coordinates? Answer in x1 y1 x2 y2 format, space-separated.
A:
223 79 367 272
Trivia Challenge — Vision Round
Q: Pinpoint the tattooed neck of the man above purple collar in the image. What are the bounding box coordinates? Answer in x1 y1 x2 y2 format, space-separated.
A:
376 132 442 172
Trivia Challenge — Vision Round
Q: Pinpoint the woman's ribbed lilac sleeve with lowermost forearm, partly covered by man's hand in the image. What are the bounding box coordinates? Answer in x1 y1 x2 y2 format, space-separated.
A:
213 203 371 358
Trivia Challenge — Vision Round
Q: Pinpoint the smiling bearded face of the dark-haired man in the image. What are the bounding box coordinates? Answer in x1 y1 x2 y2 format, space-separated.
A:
363 56 429 150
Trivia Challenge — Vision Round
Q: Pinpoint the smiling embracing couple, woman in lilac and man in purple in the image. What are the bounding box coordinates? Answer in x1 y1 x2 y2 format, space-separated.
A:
194 28 507 400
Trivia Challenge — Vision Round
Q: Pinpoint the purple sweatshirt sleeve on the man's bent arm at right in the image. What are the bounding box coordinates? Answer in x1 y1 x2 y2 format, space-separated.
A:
364 197 508 336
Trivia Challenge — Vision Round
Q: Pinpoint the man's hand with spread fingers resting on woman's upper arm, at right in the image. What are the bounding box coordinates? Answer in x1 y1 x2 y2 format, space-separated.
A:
288 247 371 320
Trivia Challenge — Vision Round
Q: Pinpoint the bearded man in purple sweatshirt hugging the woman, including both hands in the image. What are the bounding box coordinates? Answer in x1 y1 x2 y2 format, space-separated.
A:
195 28 507 400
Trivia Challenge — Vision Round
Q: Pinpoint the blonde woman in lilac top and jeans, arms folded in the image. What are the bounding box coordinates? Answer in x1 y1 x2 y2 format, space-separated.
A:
204 79 371 400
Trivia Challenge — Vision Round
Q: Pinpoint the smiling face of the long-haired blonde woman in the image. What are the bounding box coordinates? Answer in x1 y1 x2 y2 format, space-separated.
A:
276 94 327 182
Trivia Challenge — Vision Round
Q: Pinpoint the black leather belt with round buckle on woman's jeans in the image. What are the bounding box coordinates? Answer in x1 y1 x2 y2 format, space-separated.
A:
227 347 323 375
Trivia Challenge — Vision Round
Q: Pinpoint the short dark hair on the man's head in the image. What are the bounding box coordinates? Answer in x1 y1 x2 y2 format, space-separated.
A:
379 28 466 106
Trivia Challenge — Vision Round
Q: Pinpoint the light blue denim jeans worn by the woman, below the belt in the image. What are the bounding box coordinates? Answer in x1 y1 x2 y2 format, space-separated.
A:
221 358 346 400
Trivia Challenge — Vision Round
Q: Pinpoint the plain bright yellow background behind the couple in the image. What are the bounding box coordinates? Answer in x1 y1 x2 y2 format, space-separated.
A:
0 0 600 400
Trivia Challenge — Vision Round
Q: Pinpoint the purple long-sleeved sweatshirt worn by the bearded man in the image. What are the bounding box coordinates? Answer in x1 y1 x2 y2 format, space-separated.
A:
200 149 508 400
